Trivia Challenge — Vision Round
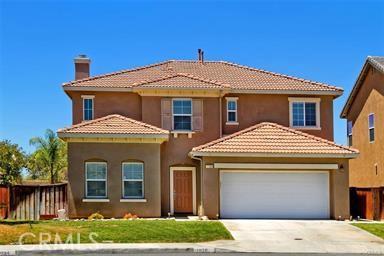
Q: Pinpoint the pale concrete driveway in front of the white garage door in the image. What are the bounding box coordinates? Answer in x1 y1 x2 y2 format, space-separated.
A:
206 220 384 255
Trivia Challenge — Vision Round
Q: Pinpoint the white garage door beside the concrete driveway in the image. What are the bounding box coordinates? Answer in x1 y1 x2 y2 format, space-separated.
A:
220 171 329 219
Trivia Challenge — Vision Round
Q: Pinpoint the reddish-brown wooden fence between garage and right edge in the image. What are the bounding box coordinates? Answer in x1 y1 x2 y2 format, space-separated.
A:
350 187 384 220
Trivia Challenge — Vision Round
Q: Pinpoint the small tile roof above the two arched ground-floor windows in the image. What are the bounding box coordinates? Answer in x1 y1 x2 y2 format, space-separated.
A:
58 114 169 137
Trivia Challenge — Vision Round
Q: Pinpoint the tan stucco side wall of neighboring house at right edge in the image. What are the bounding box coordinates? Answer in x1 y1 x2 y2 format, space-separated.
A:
347 68 384 187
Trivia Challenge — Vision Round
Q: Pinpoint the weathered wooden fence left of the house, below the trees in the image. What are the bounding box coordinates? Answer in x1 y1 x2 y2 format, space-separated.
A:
0 183 68 220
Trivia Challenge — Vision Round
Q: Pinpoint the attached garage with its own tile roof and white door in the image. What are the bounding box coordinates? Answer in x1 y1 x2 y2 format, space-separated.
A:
190 123 358 219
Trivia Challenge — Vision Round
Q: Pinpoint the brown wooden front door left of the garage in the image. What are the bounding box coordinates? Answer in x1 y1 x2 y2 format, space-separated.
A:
173 171 193 213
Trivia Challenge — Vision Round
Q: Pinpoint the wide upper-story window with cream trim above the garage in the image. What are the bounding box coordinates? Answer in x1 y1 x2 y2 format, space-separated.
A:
289 98 320 129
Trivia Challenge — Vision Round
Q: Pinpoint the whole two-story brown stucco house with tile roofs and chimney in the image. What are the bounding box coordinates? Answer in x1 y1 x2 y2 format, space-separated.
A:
58 53 358 219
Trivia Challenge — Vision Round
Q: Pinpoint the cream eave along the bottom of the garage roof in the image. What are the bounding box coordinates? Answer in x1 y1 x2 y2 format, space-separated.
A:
189 151 359 159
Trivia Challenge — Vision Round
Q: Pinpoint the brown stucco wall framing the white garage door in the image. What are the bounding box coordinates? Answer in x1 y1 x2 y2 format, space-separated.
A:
203 157 350 219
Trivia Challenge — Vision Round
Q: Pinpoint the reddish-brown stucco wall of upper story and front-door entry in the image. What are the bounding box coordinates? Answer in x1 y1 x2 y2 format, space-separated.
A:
69 91 333 215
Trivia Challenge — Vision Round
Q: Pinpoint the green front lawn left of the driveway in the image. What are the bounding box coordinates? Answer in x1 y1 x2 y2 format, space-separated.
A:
0 220 233 245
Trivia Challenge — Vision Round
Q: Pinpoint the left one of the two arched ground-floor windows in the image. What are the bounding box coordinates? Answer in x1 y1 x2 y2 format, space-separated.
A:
85 162 107 198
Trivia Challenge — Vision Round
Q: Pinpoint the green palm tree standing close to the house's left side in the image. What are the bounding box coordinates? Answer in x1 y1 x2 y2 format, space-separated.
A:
28 129 67 184
